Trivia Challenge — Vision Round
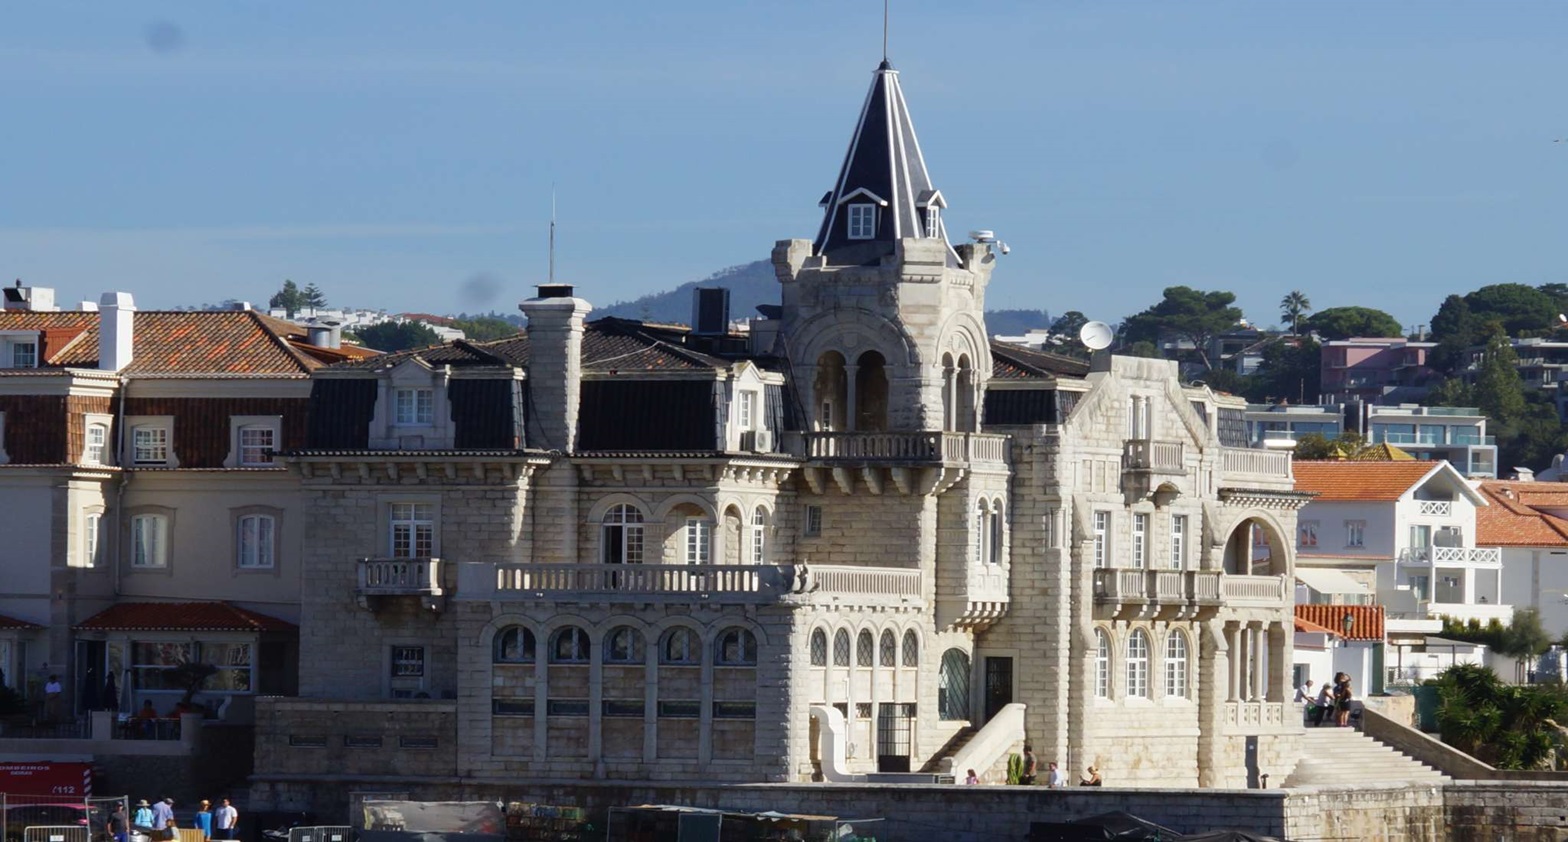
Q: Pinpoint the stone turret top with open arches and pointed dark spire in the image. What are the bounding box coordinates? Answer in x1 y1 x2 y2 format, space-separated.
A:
773 61 996 431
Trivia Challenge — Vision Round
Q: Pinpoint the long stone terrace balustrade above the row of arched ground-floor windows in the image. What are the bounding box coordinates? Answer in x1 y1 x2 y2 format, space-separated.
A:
458 563 925 607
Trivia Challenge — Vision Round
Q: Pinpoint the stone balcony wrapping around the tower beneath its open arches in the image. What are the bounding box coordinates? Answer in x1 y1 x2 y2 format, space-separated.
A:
786 430 1010 495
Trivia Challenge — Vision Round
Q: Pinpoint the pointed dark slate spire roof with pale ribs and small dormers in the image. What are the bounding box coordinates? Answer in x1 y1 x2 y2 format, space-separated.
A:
814 60 958 265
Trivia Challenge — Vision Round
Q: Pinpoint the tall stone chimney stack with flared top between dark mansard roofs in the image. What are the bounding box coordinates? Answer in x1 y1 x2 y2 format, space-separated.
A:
517 284 593 453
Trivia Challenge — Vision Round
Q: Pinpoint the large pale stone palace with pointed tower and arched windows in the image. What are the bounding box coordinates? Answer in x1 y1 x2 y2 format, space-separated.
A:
252 54 1305 806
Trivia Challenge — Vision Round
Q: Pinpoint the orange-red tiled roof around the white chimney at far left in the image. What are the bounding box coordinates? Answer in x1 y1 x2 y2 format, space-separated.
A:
0 310 321 376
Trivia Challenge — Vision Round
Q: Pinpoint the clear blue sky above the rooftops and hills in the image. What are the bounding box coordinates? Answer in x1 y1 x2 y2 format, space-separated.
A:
0 0 1568 326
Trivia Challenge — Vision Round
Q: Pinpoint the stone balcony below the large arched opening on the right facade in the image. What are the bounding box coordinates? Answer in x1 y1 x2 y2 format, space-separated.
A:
1094 568 1294 619
